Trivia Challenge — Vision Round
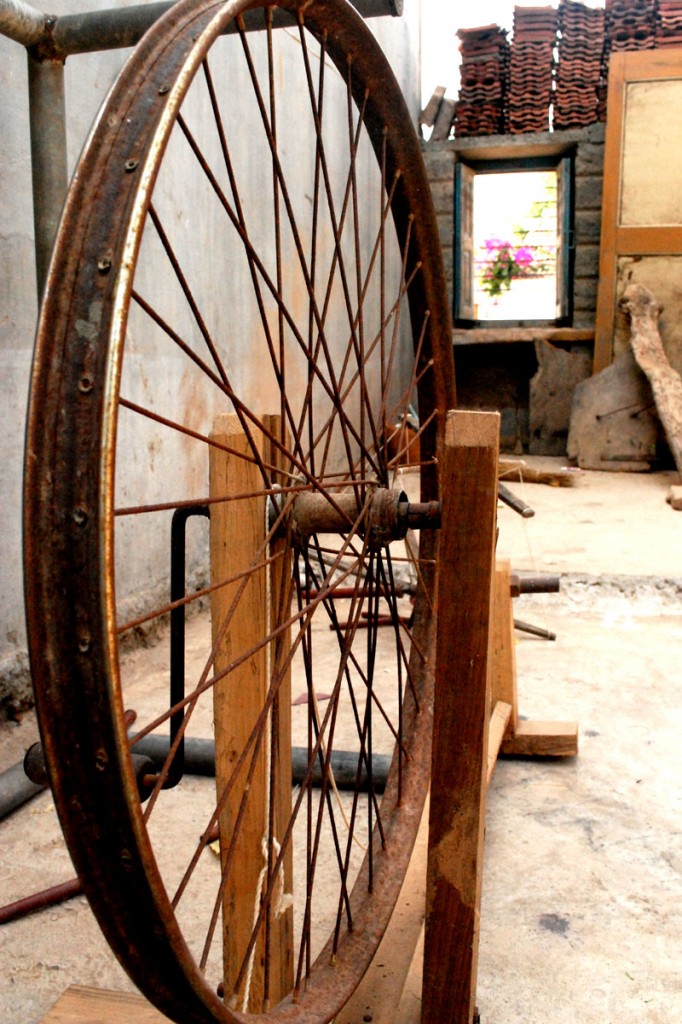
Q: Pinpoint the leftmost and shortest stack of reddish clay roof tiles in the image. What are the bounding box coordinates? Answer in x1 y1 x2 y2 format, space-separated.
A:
455 25 509 137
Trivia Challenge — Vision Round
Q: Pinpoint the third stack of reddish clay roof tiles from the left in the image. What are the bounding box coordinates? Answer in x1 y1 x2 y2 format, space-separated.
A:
554 0 606 129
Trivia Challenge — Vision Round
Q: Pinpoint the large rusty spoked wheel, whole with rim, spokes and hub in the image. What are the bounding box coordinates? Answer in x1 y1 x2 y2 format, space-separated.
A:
26 0 454 1024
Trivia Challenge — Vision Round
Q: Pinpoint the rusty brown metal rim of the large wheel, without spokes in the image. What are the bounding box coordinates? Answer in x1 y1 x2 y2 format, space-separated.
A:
26 0 454 1024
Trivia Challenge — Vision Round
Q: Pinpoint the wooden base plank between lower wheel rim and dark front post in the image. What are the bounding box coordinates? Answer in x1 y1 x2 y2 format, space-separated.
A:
334 801 429 1024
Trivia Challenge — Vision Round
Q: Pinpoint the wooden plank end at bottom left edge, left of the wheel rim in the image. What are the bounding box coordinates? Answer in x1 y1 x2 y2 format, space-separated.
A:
40 985 169 1024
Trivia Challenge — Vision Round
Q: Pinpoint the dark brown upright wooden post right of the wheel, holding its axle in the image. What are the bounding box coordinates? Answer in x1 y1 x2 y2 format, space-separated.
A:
422 412 500 1024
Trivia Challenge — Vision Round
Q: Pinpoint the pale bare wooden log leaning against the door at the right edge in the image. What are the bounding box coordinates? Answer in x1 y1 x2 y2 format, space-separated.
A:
621 282 682 473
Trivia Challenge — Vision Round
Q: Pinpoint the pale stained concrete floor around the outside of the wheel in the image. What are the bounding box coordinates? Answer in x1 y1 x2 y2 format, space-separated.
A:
0 460 682 1024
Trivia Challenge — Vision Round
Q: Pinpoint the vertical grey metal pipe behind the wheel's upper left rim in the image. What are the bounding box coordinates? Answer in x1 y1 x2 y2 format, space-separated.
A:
29 52 69 300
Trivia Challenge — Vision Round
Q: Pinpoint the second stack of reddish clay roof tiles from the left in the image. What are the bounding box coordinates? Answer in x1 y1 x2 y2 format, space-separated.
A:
507 7 557 134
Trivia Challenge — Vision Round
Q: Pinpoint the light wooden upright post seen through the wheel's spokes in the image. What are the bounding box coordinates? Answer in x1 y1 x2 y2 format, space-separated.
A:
209 415 291 1012
